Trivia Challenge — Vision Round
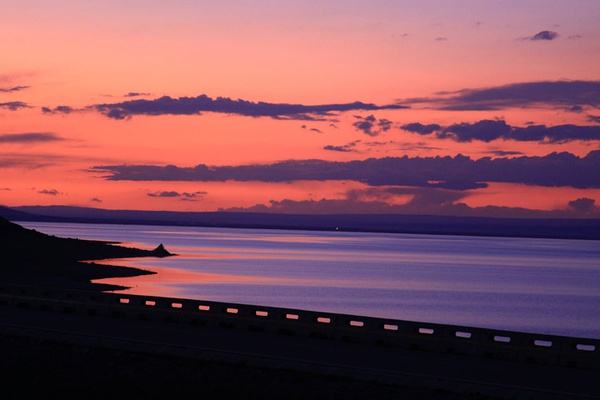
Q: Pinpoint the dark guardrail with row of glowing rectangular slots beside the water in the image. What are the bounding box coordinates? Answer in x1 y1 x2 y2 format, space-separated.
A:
0 285 600 369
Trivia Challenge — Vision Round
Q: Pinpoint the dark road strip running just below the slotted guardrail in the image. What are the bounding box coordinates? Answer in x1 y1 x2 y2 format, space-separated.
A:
0 296 600 399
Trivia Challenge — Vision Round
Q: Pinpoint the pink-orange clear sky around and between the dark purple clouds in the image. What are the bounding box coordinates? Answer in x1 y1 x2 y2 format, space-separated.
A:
0 1 600 217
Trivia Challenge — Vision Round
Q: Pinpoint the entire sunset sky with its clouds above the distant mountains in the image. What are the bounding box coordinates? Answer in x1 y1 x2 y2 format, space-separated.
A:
0 0 600 217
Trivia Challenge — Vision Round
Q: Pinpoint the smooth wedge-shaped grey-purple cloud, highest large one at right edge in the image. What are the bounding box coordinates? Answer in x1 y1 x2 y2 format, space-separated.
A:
400 81 600 111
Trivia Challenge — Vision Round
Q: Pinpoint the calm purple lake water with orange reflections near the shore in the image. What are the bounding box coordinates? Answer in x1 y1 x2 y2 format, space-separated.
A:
24 223 600 338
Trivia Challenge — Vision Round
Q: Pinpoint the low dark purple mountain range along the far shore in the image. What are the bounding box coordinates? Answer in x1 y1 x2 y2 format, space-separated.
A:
0 206 600 240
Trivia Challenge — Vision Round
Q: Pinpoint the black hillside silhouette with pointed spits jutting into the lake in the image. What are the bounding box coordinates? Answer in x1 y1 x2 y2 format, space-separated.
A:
0 217 172 288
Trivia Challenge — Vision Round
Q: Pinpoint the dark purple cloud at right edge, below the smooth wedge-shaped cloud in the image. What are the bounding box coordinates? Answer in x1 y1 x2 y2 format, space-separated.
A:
402 120 600 143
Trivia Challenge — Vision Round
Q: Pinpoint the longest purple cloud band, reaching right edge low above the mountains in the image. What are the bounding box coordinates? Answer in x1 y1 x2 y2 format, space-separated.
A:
91 150 600 190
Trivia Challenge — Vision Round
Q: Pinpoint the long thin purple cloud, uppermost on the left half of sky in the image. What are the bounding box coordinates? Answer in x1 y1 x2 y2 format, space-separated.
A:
92 95 407 121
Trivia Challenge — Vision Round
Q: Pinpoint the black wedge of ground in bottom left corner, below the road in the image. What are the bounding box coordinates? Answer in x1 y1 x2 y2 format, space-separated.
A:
0 326 476 399
